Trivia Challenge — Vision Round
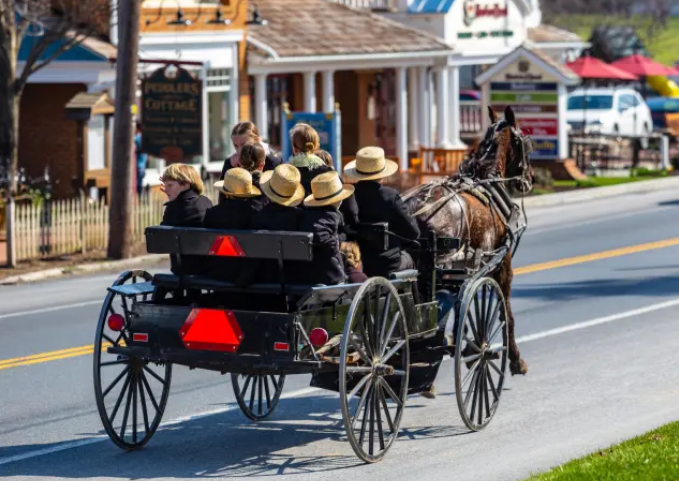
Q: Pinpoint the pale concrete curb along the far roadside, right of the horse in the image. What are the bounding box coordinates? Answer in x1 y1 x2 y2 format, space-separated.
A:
516 177 679 207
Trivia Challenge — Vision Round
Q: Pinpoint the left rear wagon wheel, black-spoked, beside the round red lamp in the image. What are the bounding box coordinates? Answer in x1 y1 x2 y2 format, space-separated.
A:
94 271 172 450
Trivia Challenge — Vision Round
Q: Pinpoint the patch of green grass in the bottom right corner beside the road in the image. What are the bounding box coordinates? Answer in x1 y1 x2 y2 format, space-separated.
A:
526 422 679 481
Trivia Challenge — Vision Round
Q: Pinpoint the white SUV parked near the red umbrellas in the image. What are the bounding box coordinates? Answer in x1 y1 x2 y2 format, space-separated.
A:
566 88 653 137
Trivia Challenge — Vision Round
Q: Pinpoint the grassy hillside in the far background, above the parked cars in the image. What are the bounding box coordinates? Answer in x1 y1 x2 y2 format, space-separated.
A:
545 15 679 66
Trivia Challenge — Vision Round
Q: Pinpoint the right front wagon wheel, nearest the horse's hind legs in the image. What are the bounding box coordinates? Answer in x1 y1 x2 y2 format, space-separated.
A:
455 277 507 431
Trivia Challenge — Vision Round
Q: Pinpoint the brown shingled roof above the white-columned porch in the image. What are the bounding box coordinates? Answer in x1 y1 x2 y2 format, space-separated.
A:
247 0 452 60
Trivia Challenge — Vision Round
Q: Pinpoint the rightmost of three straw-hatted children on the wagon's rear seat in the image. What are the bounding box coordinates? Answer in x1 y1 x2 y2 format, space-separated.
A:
299 171 354 285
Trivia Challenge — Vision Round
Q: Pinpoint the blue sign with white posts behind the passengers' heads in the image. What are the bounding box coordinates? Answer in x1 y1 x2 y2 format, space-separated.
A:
281 109 342 173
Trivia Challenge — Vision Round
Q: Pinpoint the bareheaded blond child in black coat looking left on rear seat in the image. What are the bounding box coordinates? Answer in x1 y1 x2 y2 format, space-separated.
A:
160 164 212 274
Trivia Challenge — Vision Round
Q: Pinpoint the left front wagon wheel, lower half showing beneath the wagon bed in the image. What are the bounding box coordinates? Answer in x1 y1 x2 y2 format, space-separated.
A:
231 373 285 421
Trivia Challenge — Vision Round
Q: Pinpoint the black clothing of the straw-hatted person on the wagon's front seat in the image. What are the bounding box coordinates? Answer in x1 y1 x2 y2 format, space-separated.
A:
354 181 420 277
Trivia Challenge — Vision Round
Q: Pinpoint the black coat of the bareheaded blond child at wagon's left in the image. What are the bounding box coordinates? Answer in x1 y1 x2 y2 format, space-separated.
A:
160 189 212 274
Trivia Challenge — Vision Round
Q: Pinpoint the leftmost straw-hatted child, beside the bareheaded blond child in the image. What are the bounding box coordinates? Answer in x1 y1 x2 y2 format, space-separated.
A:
203 167 269 229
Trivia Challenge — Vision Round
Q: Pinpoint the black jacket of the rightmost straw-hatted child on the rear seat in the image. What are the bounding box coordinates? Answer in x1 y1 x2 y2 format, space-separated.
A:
296 207 346 286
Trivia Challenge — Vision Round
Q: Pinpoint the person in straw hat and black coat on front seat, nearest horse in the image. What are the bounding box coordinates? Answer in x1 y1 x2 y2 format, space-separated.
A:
344 147 420 277
